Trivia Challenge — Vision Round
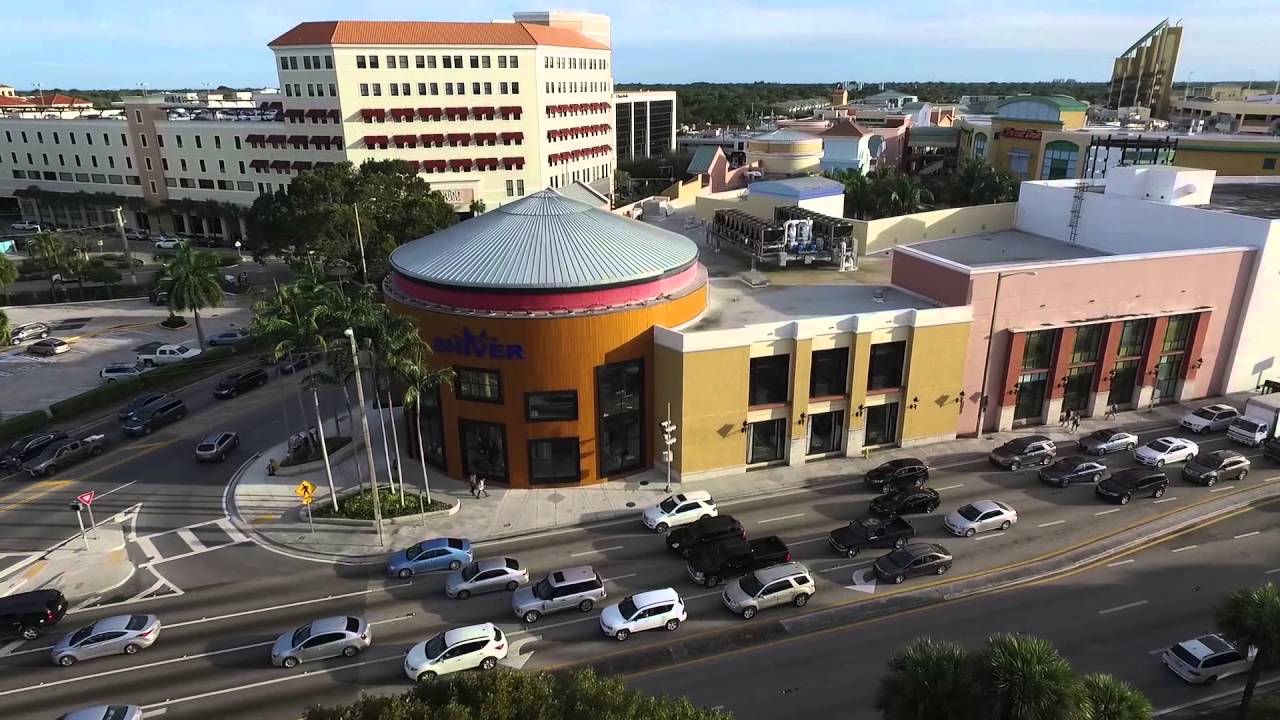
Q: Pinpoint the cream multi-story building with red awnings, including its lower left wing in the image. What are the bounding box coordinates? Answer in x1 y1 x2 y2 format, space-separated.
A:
0 13 616 240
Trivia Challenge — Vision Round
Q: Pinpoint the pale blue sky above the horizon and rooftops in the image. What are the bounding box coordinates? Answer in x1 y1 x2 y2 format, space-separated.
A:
0 0 1280 90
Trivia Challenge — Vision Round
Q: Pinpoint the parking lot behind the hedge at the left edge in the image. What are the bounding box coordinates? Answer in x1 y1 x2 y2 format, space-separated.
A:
0 297 251 419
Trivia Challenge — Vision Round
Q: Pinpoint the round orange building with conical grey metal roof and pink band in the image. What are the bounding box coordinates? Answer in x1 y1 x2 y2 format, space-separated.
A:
383 190 708 487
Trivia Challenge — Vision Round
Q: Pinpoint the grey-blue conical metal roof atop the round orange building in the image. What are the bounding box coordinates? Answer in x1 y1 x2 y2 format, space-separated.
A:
390 190 698 291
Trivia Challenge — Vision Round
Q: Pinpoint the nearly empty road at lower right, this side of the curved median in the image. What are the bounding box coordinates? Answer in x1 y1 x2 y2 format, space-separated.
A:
628 505 1280 719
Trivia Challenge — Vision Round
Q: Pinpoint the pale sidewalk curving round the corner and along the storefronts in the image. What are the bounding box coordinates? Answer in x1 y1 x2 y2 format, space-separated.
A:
228 395 1243 561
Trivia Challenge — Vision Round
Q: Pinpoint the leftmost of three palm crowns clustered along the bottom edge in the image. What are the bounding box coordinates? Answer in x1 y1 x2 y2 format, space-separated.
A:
876 638 973 720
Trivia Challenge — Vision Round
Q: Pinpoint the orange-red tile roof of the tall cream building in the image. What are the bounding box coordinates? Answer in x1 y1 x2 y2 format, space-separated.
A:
268 20 609 50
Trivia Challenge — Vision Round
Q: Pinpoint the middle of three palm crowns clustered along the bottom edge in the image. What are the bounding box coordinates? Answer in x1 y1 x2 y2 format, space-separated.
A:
974 633 1088 720
